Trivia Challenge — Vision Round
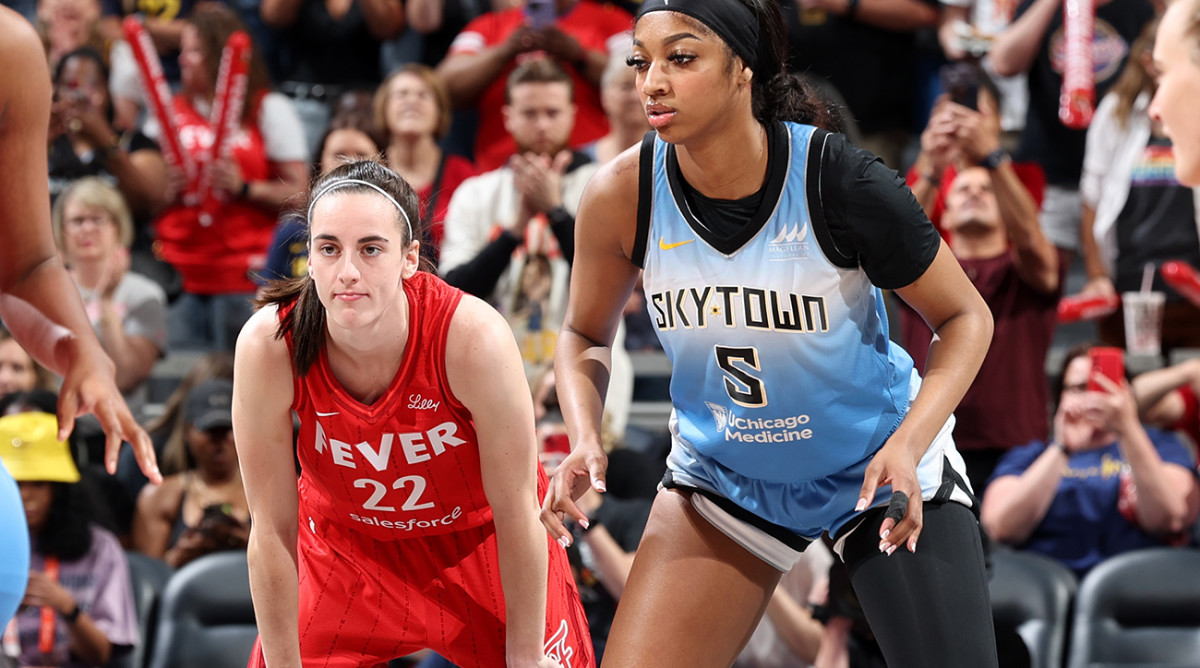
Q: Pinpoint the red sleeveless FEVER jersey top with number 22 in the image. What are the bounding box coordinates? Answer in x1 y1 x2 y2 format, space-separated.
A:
281 271 492 541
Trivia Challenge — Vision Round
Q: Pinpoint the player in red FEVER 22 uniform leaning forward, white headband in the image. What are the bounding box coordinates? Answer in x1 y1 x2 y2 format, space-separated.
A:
234 157 594 668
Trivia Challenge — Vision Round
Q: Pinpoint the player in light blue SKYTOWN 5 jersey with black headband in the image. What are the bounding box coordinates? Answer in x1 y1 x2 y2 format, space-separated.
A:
542 0 997 668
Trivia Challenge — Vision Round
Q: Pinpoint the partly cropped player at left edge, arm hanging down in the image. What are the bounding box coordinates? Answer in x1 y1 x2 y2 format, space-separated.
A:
0 6 162 627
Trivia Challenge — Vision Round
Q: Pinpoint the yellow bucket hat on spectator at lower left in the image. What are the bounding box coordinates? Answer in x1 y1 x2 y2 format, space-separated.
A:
0 413 79 482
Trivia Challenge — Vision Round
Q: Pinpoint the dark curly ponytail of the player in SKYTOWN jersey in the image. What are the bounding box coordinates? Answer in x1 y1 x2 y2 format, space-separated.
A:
739 0 844 132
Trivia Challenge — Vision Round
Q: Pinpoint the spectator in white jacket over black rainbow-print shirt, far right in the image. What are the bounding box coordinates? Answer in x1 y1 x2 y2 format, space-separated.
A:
1079 20 1200 351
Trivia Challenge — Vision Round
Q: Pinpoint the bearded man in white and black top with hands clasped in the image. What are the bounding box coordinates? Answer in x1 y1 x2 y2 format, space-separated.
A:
439 59 595 386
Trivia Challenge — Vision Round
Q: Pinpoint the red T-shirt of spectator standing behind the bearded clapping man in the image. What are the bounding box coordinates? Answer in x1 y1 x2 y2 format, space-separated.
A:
450 0 634 171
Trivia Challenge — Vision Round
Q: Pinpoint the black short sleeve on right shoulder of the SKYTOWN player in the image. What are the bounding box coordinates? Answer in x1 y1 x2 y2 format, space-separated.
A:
821 134 941 290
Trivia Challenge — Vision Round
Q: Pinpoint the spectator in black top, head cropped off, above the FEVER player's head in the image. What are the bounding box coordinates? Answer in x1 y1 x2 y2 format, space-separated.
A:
259 0 404 157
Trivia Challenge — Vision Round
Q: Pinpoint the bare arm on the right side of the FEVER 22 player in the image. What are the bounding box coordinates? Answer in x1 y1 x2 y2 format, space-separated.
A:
446 296 554 667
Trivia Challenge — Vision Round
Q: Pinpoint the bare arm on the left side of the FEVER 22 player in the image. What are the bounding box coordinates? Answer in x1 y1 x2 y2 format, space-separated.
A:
233 308 300 668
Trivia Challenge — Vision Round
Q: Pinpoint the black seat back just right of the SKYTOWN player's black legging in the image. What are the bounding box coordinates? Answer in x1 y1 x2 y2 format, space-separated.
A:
989 548 1076 668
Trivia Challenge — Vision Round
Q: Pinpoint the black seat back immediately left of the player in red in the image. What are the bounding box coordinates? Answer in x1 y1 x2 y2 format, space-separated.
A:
149 552 258 668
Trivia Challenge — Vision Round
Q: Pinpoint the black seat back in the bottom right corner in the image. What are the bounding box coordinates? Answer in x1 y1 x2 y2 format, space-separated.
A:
1068 547 1200 668
